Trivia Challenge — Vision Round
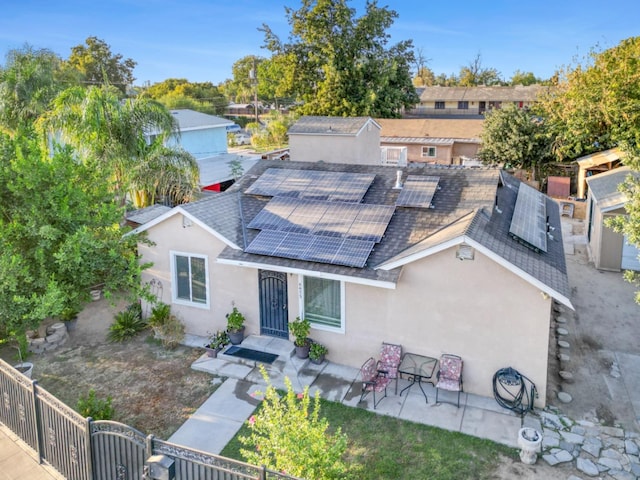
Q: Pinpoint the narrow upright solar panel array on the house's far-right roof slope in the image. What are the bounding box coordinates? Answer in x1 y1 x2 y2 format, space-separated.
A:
509 183 547 252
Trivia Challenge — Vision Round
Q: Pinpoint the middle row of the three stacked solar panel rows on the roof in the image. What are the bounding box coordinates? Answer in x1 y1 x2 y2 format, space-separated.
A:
248 197 395 243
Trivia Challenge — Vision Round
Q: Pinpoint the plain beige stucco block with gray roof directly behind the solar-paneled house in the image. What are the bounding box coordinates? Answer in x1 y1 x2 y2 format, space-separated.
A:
288 116 380 165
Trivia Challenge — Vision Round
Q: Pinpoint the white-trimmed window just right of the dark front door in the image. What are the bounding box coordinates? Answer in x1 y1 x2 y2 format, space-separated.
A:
300 276 344 332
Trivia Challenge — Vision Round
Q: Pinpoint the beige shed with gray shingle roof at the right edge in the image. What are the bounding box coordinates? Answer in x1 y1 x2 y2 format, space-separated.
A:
586 167 640 272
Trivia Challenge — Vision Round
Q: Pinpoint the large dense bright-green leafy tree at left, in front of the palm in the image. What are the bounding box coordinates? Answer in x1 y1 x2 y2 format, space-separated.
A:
0 131 144 334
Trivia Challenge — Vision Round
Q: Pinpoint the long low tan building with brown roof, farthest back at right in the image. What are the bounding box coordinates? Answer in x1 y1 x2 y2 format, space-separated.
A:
407 85 548 116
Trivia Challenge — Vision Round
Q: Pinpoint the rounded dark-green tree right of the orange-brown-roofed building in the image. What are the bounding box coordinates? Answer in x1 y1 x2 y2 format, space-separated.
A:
479 104 551 180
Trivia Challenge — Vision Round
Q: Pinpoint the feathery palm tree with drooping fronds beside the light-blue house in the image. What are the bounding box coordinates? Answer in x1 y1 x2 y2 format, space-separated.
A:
39 85 198 207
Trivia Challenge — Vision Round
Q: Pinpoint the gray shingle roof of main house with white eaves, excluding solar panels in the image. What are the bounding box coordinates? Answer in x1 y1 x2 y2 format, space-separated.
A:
132 160 571 306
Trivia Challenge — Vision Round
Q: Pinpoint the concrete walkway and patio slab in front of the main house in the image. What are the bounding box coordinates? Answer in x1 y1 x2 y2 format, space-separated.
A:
169 336 522 454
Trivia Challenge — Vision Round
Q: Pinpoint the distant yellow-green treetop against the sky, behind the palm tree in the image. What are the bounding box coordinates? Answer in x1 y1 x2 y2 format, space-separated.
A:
68 37 137 94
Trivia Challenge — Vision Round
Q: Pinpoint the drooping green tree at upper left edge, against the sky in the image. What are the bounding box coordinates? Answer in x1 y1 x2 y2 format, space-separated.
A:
0 45 73 134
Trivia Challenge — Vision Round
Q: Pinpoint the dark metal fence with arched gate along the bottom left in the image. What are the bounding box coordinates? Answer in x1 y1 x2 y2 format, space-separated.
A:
0 360 296 480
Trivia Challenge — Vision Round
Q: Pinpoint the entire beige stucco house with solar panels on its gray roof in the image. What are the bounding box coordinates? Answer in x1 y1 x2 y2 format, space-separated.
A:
131 156 572 406
